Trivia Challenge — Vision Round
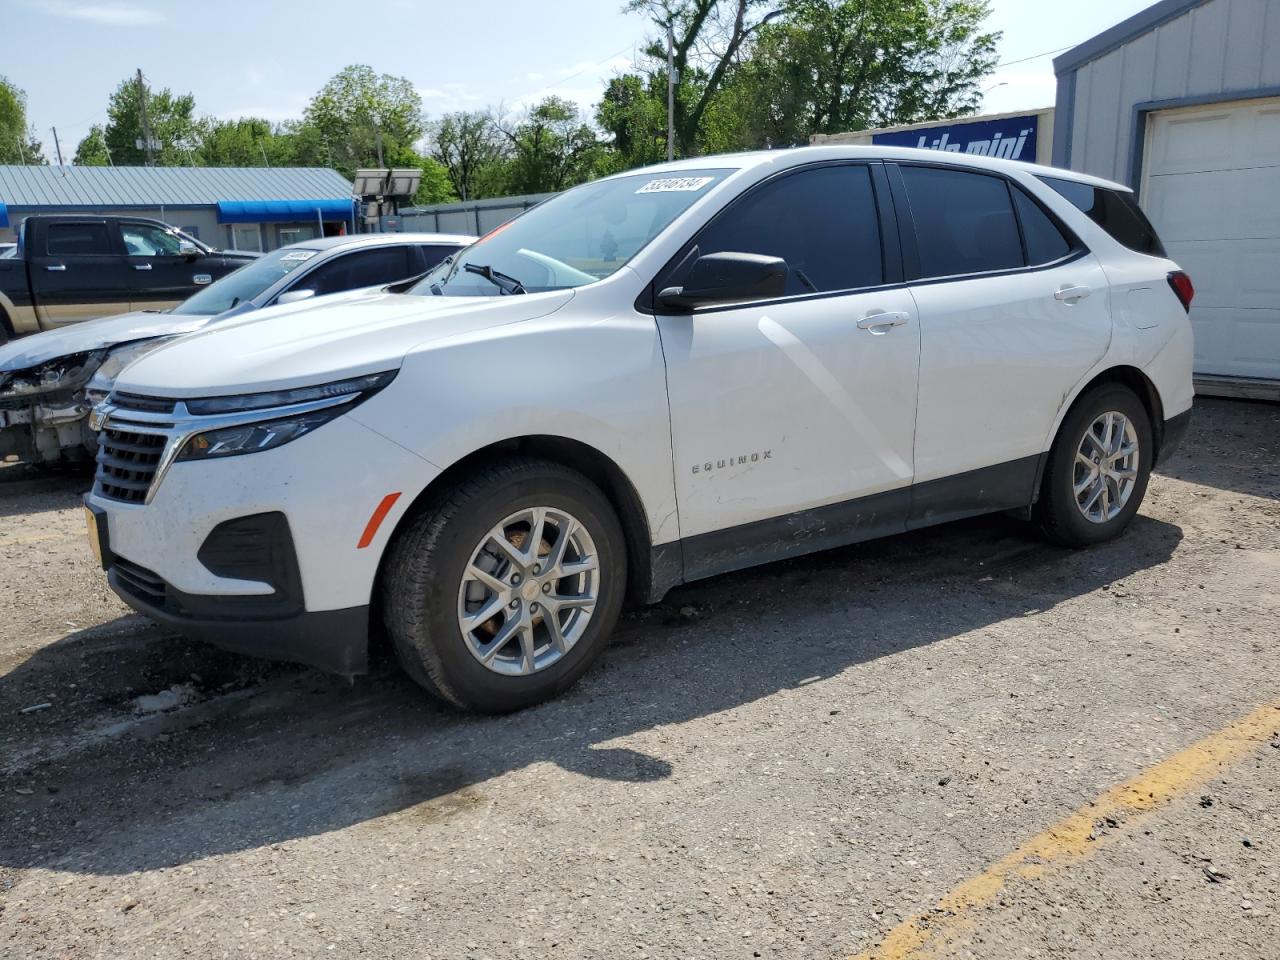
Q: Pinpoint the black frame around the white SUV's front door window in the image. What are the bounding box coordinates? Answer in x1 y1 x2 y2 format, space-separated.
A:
635 160 905 316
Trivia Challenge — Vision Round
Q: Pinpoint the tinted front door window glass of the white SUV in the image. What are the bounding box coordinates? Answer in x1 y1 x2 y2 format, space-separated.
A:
680 166 884 296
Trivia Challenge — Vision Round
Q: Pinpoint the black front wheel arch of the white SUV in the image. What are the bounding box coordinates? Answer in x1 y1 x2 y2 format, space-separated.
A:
374 434 672 616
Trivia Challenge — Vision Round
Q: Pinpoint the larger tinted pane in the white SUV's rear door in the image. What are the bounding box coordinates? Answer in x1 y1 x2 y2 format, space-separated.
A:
900 166 1024 276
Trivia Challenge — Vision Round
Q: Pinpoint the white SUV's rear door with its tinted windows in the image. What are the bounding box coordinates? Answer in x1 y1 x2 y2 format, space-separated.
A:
893 164 1111 526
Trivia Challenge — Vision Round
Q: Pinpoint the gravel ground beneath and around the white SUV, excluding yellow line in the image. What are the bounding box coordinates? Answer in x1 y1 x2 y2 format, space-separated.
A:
0 401 1280 960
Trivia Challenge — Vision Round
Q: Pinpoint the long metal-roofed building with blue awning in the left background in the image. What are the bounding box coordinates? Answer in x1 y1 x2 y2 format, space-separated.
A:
0 165 358 251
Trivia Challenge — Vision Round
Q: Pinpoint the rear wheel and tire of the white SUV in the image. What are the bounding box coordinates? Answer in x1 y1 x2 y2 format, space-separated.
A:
1034 384 1155 547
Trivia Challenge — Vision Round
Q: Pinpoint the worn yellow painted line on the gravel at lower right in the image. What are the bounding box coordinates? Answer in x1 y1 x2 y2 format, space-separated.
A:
851 700 1280 960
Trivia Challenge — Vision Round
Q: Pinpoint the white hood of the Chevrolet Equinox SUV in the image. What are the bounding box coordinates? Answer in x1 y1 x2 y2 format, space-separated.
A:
116 289 573 397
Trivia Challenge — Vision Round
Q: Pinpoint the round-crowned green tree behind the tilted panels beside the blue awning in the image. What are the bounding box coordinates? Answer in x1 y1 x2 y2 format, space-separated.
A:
300 64 424 177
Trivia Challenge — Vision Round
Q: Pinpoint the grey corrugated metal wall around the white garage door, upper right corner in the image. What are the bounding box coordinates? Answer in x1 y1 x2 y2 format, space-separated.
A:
1057 0 1280 187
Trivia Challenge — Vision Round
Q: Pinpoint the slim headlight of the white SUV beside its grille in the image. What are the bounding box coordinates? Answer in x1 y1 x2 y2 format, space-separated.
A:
177 370 396 461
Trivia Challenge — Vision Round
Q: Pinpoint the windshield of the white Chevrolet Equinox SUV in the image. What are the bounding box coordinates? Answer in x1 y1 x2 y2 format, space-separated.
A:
410 169 731 297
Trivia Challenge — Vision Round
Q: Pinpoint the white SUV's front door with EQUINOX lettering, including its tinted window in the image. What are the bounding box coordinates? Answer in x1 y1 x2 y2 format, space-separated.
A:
655 164 919 579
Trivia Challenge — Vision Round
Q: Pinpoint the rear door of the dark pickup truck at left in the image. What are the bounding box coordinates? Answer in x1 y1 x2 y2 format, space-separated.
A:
27 219 133 328
